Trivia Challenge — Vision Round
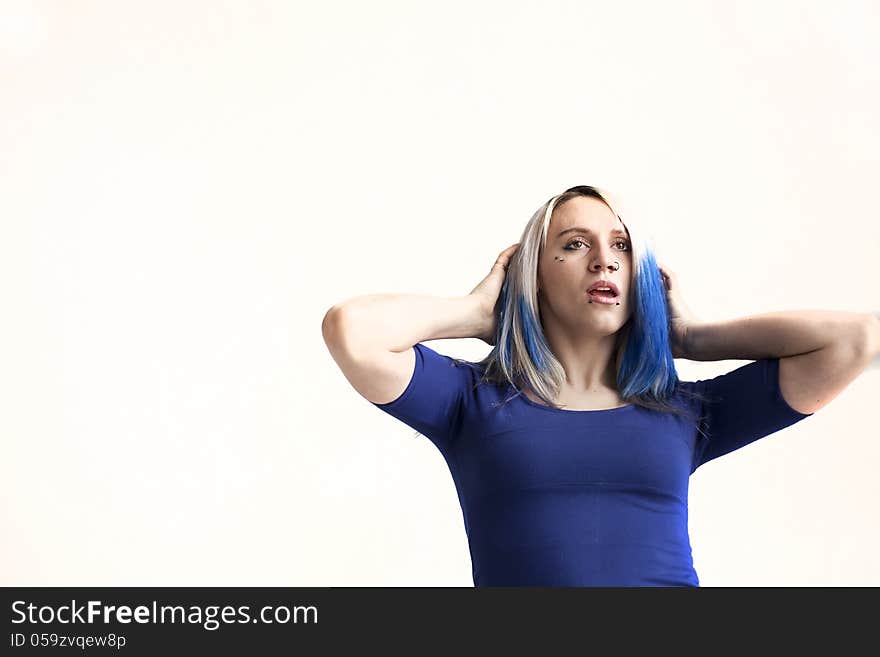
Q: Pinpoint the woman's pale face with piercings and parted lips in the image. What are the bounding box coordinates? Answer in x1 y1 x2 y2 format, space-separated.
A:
538 196 633 335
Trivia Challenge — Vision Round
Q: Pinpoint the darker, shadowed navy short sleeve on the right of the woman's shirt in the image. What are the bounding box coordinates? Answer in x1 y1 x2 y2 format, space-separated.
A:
691 358 812 472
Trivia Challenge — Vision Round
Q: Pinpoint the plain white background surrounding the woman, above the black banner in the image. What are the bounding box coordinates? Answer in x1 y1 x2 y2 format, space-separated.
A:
0 0 880 586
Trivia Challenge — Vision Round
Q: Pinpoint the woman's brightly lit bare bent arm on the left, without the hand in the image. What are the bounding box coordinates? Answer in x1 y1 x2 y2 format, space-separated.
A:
321 294 492 404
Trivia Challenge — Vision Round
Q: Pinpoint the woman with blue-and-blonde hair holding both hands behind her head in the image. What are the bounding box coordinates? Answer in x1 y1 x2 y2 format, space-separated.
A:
323 186 880 586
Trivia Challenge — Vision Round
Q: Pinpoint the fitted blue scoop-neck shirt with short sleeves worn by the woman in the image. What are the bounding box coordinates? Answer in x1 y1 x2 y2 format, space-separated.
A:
374 343 812 586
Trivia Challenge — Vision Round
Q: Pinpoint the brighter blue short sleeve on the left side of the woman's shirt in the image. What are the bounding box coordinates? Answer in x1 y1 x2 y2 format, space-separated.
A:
373 342 474 452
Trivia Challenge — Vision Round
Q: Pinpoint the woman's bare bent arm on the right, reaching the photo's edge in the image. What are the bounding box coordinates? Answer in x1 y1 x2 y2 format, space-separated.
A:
682 310 880 413
